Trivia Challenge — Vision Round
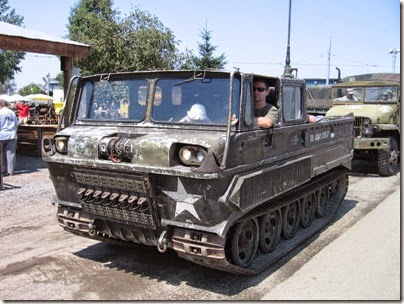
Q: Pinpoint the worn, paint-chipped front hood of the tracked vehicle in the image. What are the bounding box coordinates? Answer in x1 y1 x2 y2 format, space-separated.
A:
56 126 226 167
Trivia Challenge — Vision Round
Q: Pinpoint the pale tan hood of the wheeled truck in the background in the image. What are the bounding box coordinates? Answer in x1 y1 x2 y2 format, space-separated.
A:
326 104 396 124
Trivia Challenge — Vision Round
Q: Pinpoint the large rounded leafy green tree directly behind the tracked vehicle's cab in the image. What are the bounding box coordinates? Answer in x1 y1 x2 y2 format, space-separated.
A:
68 0 179 75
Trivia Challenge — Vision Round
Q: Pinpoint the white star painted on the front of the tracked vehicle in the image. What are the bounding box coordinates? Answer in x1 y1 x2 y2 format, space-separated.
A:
163 178 202 221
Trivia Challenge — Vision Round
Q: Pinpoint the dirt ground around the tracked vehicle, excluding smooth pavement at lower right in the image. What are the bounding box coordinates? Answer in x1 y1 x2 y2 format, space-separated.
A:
0 154 400 301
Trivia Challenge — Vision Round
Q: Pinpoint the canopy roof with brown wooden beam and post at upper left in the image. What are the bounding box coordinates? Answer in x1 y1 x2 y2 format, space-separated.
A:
0 21 90 94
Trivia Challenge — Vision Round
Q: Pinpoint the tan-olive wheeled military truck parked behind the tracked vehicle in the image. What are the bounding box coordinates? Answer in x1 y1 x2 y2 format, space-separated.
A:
326 75 400 176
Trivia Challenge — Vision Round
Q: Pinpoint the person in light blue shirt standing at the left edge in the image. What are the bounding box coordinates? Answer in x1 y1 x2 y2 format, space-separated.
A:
0 99 18 176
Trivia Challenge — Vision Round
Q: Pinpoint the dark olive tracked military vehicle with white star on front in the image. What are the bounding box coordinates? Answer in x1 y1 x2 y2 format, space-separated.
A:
43 70 353 274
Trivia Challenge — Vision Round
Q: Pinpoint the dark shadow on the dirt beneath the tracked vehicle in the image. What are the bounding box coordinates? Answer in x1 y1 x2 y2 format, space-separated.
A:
74 200 358 300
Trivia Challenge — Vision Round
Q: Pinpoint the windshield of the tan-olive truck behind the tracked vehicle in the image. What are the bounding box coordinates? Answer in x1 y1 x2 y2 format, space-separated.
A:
332 86 398 103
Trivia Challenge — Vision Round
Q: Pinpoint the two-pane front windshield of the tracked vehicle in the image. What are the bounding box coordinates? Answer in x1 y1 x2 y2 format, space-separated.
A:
77 74 240 125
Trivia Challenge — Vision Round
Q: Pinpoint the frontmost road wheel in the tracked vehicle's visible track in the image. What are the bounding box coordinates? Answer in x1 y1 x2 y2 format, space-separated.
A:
231 218 259 267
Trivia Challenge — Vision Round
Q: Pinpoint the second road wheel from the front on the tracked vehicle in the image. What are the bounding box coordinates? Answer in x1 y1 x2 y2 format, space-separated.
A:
259 209 282 253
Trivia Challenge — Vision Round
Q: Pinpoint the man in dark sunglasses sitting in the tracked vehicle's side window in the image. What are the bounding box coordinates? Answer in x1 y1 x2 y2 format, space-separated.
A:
253 79 278 129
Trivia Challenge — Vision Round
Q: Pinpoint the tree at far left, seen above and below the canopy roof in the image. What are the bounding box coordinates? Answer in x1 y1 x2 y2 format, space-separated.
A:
0 0 25 84
